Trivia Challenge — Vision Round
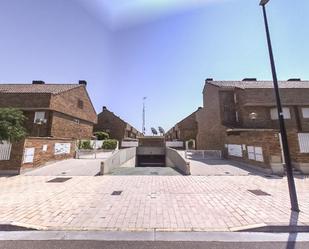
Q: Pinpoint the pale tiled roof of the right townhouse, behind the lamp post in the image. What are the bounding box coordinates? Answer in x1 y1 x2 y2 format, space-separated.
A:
206 81 309 89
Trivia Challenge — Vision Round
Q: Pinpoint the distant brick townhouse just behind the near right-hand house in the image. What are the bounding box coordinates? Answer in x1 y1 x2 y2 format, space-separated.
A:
165 107 202 141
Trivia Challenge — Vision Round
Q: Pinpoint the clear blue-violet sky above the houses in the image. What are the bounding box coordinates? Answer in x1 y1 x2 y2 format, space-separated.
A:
0 0 309 133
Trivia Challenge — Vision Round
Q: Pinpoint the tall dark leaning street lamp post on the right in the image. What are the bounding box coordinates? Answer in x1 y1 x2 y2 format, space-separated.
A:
260 0 299 212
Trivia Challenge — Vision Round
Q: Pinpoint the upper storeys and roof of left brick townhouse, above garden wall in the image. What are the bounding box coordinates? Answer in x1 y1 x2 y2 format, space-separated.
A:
0 84 97 139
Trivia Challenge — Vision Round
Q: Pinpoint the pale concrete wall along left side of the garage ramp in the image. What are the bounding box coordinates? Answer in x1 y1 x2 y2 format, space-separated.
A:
100 148 136 175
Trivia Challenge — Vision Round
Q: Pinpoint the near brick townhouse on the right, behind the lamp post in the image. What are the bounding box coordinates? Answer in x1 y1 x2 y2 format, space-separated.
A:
197 78 309 174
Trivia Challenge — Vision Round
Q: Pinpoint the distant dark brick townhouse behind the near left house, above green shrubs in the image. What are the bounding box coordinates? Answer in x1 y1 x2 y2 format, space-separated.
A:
94 106 143 141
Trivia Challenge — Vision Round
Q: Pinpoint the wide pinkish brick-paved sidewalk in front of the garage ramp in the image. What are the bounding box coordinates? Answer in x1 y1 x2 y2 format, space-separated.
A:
0 175 309 231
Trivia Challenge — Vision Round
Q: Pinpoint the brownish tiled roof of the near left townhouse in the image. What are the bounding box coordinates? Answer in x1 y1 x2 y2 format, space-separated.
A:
0 84 81 94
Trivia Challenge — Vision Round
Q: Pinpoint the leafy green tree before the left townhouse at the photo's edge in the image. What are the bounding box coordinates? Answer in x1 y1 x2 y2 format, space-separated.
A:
0 108 27 142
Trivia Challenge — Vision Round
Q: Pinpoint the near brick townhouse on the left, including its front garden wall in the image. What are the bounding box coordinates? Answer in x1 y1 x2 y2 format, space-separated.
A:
0 81 97 174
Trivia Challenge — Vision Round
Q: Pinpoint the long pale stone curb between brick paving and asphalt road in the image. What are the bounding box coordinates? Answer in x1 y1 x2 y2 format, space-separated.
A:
0 231 309 242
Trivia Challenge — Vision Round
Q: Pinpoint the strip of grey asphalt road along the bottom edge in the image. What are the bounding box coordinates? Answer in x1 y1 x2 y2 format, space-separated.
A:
0 240 309 249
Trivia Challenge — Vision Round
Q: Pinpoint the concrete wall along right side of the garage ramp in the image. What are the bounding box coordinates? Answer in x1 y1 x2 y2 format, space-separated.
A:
165 148 191 175
